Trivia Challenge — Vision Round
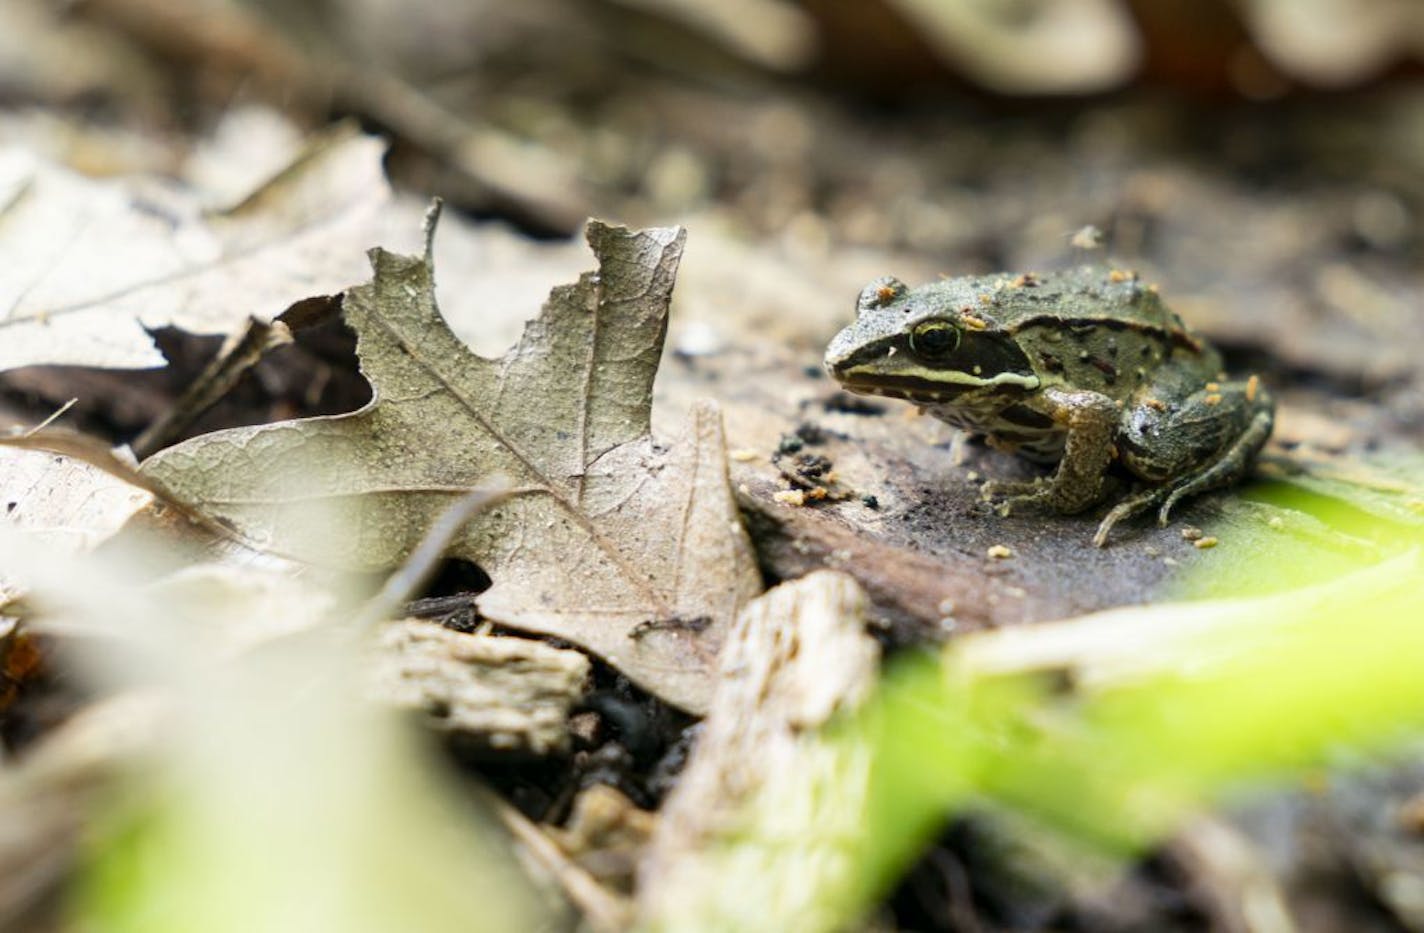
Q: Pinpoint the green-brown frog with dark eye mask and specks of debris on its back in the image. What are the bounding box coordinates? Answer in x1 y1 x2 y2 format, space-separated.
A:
824 265 1276 547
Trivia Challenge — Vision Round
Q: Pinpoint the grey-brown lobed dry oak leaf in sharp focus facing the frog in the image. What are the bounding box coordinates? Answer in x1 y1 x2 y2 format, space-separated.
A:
142 212 760 712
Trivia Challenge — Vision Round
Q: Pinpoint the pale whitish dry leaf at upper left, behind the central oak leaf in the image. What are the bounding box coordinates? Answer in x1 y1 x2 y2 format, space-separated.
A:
0 125 390 370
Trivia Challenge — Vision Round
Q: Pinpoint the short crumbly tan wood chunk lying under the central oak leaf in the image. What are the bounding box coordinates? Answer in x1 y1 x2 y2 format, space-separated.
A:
373 620 588 755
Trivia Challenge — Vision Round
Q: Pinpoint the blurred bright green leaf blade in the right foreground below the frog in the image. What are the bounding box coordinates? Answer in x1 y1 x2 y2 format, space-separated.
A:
745 455 1424 929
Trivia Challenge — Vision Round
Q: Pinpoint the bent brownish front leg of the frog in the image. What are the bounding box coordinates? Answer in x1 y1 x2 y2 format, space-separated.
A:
984 389 1119 514
